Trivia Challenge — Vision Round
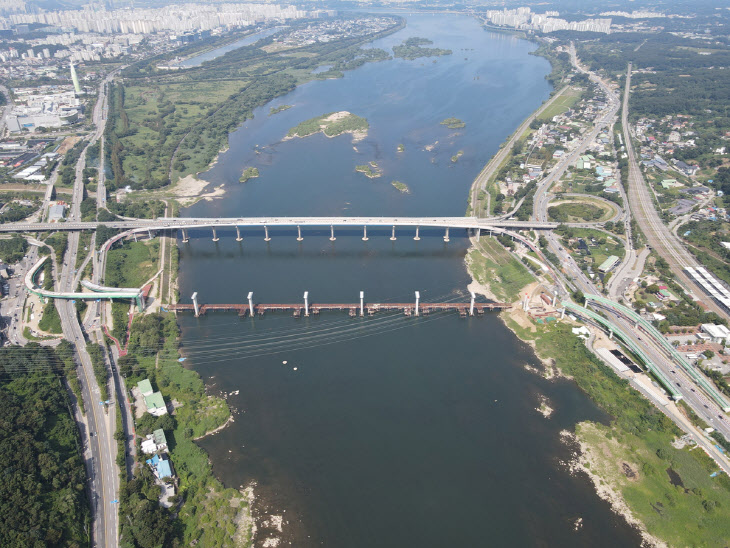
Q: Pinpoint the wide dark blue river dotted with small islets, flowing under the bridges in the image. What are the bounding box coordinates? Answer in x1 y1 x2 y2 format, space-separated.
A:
180 14 639 548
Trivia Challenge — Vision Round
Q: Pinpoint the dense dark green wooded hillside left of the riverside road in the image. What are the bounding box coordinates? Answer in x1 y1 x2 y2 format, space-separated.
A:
0 343 89 548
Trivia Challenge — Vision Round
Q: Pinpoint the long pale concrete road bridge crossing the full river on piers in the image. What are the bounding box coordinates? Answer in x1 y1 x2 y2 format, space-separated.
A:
0 217 601 232
